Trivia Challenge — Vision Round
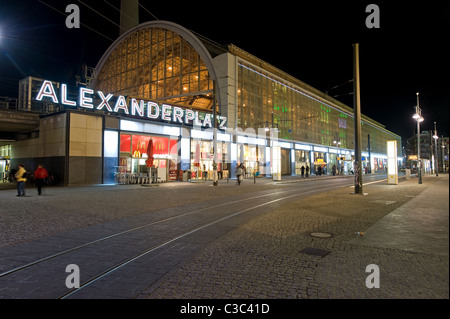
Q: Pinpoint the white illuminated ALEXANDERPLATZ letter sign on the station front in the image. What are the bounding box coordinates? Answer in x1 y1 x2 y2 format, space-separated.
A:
36 80 227 130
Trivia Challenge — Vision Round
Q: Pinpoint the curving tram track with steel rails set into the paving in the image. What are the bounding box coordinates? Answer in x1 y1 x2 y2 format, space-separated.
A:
0 178 386 299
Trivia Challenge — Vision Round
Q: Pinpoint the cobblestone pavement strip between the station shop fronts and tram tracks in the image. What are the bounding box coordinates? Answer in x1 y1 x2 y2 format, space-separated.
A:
0 180 284 247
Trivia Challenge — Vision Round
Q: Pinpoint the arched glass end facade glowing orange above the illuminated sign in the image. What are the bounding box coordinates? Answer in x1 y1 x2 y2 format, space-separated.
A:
94 27 213 110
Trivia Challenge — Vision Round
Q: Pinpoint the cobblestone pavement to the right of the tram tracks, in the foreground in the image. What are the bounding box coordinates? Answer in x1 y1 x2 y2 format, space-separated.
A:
139 175 449 299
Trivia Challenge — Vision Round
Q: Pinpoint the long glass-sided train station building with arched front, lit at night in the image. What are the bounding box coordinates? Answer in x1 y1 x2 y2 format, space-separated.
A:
3 21 402 185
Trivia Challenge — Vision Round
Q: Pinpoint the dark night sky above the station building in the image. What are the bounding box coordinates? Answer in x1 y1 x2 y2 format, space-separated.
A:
0 0 450 140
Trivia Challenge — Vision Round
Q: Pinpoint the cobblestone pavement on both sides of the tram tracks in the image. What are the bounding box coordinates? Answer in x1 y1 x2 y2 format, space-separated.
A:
0 175 449 300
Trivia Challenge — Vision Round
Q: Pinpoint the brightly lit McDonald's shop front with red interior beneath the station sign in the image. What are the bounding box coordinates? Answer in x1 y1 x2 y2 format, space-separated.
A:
110 119 236 183
